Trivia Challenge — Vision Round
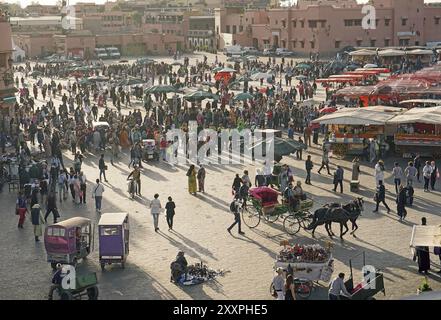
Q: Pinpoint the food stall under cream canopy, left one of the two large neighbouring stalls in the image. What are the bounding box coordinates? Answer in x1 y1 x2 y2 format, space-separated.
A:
312 106 404 156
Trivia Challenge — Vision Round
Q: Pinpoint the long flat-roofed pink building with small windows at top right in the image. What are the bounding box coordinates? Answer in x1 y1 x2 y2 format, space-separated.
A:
215 0 441 55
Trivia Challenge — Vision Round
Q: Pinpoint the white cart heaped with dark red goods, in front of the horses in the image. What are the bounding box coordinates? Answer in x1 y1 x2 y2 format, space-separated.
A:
274 244 334 282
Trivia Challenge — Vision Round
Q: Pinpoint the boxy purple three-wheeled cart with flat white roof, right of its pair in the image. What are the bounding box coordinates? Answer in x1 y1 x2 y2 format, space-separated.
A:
98 212 129 271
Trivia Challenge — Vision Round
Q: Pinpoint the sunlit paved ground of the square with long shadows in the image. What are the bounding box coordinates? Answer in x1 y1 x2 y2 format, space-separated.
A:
0 52 441 299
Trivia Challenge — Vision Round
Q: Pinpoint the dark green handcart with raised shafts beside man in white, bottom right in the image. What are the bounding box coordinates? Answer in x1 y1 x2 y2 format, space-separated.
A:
340 251 386 300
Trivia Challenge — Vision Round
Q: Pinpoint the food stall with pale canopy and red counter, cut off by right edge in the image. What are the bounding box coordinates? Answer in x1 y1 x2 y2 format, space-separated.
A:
388 106 441 158
